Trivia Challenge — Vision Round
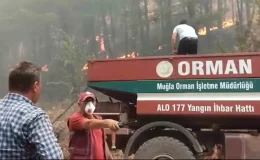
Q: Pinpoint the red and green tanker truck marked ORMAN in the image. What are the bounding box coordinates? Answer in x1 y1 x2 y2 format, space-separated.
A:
87 53 260 159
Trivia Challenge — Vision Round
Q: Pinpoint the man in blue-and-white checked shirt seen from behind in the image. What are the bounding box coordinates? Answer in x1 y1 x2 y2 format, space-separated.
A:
0 62 63 159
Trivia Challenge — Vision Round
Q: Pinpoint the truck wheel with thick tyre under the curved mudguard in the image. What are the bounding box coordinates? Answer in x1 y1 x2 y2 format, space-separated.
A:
135 137 196 160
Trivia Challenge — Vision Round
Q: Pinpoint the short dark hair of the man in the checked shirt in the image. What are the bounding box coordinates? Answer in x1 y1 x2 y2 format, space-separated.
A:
9 62 42 93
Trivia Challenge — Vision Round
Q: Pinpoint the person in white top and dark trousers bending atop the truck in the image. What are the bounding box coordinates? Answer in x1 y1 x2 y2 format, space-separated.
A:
172 20 198 55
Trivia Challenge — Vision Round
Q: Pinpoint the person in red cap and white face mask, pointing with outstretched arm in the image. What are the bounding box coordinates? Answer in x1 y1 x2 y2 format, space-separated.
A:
68 92 119 160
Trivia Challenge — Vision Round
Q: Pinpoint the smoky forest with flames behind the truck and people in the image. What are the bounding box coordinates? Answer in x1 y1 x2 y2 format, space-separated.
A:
0 0 260 105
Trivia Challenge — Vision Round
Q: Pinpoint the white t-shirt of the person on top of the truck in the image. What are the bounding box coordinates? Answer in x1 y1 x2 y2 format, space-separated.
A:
173 24 198 40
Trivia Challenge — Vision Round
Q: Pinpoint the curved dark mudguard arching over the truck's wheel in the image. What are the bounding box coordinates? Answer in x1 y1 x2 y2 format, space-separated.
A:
124 121 203 159
